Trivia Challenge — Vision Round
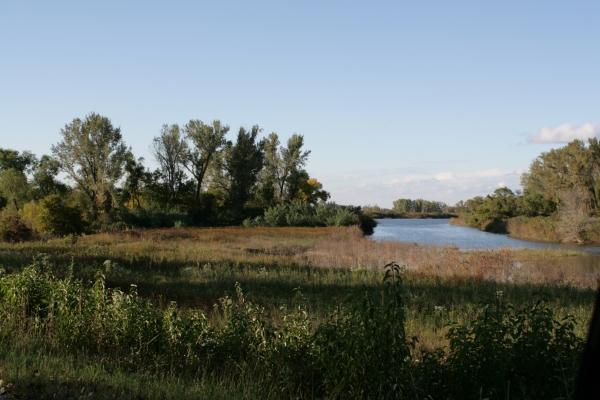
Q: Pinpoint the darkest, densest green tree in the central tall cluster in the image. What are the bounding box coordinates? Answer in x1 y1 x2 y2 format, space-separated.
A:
223 125 264 210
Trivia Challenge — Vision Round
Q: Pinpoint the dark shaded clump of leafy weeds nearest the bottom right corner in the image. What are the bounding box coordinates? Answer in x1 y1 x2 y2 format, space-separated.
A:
445 292 584 399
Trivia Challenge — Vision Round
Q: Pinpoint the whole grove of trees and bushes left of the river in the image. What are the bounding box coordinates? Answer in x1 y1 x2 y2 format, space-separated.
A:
0 113 374 242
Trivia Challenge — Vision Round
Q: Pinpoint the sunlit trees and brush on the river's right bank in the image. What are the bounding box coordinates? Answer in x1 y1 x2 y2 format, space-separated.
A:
454 138 600 243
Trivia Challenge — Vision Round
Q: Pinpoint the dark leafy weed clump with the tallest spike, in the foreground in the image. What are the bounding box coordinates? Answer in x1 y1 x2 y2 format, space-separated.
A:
315 263 414 399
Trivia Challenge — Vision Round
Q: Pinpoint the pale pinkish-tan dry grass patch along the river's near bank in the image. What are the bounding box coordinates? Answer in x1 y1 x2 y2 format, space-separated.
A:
302 236 600 289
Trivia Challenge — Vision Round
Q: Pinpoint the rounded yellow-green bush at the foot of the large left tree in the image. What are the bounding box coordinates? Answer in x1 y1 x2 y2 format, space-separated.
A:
36 194 84 236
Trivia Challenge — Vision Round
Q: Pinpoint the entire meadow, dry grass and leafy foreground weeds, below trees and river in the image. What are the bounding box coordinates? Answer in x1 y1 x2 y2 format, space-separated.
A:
0 228 594 399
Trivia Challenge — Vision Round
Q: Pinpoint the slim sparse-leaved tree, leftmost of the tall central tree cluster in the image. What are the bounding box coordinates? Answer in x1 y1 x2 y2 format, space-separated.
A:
151 124 187 207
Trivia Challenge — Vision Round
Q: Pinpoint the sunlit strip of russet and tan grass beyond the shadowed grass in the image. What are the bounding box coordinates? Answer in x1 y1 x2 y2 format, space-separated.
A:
0 227 600 289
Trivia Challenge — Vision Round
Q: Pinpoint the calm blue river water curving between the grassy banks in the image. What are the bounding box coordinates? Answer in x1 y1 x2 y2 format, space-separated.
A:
371 219 600 253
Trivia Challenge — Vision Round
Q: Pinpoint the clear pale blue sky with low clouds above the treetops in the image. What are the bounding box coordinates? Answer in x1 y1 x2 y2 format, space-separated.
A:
0 0 600 207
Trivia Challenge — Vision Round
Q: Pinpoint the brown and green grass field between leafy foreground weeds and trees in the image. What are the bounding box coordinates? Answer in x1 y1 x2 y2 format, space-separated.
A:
0 227 598 388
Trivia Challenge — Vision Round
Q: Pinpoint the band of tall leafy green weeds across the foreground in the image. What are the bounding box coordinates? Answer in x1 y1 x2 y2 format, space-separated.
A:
0 259 583 400
